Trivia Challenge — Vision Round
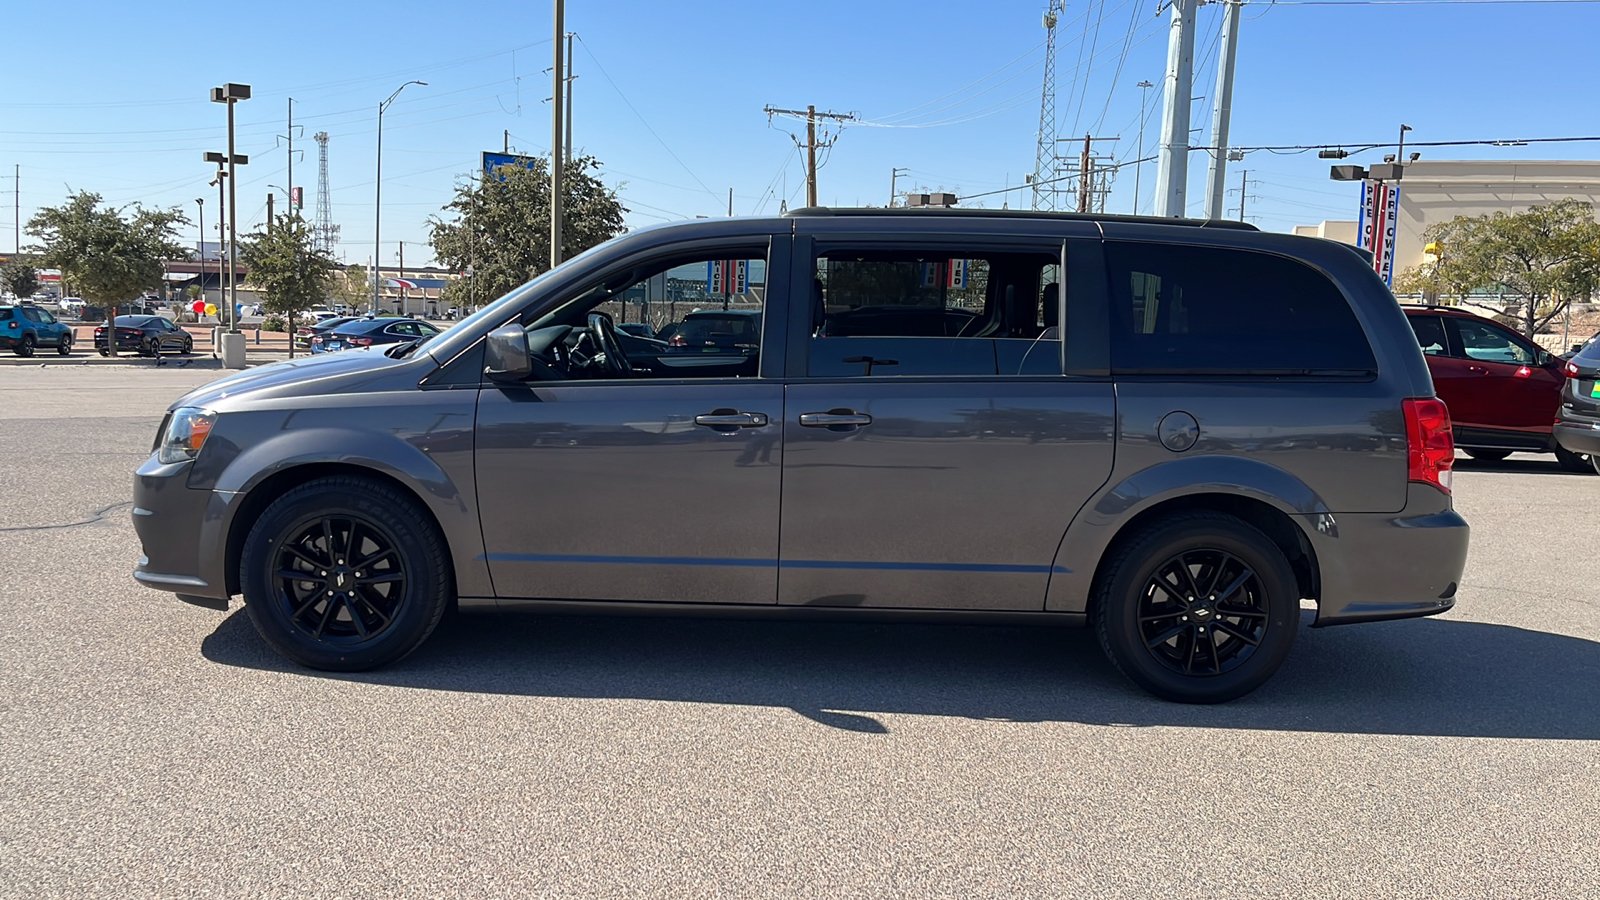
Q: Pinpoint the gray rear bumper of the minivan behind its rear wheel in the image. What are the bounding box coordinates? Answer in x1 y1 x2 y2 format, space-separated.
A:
1301 484 1470 626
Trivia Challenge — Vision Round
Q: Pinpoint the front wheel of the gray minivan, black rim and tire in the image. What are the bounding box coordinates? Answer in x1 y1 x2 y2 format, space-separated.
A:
238 476 454 671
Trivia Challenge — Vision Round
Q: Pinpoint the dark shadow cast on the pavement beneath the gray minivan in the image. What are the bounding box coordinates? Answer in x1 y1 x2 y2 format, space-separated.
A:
202 610 1600 740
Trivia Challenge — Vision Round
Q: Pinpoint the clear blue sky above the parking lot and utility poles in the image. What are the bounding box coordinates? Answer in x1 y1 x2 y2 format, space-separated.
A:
0 0 1600 264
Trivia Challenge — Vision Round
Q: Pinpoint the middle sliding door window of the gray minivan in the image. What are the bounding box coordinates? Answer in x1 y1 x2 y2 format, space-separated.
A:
806 247 1061 378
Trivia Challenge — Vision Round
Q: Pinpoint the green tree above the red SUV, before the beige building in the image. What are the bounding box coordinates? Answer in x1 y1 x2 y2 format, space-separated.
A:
1398 200 1600 338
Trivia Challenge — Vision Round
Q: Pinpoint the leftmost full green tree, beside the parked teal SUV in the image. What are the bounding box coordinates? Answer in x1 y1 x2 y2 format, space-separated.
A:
27 191 189 356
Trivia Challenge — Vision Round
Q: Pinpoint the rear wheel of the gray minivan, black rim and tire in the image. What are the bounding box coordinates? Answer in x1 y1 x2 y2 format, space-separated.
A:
1091 512 1299 703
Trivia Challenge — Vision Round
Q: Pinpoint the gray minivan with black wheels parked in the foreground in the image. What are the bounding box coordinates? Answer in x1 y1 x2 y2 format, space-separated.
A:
134 208 1467 701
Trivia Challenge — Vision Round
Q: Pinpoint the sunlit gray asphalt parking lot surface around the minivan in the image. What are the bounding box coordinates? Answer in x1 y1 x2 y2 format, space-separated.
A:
0 367 1600 898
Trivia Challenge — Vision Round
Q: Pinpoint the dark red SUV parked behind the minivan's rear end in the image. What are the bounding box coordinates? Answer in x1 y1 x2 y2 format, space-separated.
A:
1405 306 1592 472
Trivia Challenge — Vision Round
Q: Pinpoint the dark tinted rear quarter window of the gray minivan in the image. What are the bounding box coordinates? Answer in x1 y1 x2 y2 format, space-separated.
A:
1106 242 1378 375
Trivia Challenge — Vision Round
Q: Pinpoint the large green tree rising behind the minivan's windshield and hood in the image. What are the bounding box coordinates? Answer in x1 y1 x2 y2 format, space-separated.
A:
429 157 627 306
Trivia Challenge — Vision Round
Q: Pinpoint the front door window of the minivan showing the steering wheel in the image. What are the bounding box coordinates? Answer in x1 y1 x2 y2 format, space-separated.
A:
528 247 768 380
